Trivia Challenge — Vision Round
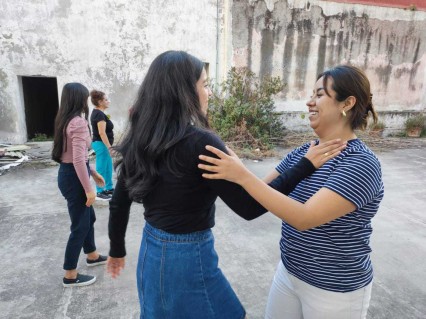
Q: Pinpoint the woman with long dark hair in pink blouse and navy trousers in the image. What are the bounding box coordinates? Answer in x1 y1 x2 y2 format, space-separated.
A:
52 83 106 287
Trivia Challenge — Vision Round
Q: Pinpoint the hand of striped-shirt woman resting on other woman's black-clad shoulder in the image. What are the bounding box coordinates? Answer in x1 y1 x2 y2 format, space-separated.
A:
198 145 251 185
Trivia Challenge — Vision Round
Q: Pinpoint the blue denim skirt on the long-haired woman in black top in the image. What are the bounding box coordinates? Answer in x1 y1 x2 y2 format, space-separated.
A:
136 223 245 319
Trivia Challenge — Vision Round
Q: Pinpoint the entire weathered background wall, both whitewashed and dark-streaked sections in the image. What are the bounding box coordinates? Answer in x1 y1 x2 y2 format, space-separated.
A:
0 0 426 143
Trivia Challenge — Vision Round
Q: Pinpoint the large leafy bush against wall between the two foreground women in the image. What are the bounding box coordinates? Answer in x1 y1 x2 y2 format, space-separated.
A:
209 68 284 150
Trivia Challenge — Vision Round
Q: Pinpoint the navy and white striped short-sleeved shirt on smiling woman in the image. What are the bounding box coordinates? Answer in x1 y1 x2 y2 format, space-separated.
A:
276 139 383 292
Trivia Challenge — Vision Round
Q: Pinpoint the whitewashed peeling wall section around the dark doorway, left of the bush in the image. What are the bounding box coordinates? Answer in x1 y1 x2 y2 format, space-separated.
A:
0 0 218 143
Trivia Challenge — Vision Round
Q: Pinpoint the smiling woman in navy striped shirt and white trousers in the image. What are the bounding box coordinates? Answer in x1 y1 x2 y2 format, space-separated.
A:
199 66 383 319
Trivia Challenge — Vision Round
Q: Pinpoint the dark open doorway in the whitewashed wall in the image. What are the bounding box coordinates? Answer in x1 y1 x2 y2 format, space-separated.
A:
22 76 59 140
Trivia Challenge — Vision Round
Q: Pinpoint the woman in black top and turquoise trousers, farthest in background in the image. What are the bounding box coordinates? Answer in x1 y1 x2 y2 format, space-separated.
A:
90 90 114 200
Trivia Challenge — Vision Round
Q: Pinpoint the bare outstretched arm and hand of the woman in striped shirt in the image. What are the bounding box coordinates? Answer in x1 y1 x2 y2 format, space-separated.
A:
199 146 356 230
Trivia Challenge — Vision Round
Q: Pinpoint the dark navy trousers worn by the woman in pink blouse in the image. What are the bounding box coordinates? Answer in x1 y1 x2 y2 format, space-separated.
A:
58 163 96 270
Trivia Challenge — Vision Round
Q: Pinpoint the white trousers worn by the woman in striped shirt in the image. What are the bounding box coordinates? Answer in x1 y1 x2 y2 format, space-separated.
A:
265 261 372 319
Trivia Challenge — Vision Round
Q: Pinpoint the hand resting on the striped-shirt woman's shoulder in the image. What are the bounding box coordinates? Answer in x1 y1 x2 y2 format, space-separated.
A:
305 139 346 168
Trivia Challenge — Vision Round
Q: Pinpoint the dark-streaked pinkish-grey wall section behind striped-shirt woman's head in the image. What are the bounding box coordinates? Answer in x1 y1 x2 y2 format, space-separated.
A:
232 0 426 130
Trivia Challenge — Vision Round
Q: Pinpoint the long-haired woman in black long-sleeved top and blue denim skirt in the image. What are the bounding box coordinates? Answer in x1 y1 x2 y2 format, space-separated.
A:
107 51 346 319
